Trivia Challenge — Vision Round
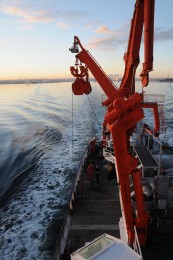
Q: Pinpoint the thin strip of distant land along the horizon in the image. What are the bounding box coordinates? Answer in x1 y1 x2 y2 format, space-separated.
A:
0 78 173 85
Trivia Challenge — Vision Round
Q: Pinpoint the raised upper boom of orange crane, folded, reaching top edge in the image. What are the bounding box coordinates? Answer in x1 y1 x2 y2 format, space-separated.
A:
120 0 155 97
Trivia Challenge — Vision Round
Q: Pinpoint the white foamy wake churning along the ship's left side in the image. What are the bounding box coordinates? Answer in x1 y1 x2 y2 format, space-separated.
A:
0 137 76 260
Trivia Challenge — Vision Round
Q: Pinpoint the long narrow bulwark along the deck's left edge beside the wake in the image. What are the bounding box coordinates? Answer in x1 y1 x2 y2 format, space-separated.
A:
53 143 89 260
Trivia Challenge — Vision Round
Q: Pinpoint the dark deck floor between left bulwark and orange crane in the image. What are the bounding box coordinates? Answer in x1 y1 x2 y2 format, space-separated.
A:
63 151 121 255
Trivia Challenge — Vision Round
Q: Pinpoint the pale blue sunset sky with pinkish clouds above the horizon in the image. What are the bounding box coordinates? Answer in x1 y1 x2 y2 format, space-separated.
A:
0 0 173 80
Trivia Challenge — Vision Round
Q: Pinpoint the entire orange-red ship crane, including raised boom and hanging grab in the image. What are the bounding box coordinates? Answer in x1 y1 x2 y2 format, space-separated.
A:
70 0 159 245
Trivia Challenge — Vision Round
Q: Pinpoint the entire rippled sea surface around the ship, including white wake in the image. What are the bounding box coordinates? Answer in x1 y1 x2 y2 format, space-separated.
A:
0 80 173 260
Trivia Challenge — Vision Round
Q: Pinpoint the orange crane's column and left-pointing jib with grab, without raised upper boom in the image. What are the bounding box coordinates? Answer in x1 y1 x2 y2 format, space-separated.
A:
70 36 148 244
